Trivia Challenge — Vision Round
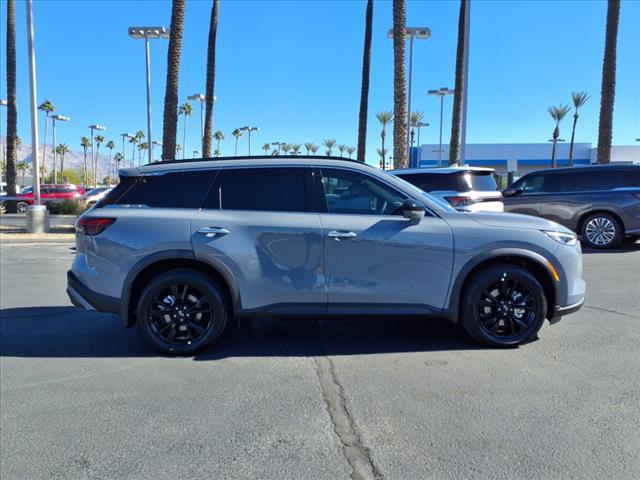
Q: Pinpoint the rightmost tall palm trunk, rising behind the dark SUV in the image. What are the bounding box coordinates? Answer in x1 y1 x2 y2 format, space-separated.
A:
597 0 620 163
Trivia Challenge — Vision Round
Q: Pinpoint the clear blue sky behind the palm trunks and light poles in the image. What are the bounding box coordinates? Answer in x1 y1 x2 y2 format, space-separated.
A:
0 0 640 163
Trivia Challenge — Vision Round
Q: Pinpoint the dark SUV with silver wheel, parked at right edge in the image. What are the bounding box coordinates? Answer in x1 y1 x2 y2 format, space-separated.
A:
503 165 640 248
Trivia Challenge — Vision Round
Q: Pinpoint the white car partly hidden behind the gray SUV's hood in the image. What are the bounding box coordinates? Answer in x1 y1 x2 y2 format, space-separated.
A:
389 167 504 212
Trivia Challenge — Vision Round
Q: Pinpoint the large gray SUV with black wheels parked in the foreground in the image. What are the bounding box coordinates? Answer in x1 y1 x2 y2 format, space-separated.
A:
67 157 585 354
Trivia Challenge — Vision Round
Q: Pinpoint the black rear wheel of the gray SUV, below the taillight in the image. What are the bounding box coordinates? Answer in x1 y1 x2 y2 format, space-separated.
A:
137 269 228 355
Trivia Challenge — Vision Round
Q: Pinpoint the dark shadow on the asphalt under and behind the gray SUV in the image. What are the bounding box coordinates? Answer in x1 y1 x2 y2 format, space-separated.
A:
0 307 482 361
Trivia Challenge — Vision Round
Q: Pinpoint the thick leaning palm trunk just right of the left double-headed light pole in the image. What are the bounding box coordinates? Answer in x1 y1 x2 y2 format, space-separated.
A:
162 0 186 160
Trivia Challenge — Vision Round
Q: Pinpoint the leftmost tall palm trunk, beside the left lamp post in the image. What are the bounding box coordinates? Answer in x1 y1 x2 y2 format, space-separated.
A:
6 0 18 208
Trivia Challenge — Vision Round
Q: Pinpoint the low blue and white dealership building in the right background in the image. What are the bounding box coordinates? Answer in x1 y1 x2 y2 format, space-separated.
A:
410 143 640 178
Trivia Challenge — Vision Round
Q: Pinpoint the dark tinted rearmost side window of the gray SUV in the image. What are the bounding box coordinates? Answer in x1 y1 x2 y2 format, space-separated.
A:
99 170 217 208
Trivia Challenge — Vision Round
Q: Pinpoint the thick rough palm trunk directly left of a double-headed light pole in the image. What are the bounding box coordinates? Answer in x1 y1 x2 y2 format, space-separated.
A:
393 0 407 169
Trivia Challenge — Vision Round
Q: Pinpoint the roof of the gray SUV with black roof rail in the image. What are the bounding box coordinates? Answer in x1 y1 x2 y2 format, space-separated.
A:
119 155 375 176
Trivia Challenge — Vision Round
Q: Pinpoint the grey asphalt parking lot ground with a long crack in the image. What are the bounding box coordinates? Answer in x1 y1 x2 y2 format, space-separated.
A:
0 244 640 480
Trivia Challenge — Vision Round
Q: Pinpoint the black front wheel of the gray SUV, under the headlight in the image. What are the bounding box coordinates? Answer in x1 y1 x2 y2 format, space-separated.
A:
461 265 547 348
